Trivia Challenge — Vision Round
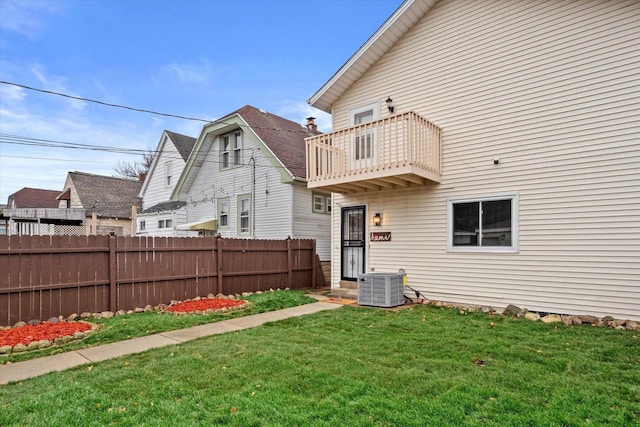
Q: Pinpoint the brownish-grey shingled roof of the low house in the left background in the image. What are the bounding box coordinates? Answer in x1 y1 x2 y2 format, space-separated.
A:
69 172 142 218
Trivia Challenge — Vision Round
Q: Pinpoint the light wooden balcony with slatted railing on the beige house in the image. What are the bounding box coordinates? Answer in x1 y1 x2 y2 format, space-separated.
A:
306 112 442 194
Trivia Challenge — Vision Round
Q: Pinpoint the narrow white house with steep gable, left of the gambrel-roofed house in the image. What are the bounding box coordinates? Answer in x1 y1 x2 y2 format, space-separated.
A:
136 130 198 236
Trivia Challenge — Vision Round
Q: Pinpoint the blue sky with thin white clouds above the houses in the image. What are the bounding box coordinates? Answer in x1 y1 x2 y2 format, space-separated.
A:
0 0 401 204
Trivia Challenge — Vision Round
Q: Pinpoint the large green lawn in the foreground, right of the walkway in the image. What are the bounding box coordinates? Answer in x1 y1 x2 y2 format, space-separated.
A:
0 306 640 426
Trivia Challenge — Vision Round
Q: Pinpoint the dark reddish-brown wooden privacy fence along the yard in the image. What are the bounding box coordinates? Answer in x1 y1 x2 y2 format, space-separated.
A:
0 235 324 325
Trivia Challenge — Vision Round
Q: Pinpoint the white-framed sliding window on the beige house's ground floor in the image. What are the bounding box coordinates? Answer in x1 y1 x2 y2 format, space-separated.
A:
447 194 518 252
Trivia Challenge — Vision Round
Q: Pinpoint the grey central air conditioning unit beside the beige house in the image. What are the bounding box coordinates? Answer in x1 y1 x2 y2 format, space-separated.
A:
358 273 404 308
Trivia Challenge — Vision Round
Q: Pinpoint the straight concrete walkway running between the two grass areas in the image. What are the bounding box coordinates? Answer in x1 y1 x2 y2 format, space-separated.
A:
0 295 340 384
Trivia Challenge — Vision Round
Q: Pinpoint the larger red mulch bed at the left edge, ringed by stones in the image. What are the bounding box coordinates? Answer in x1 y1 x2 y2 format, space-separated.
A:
0 322 91 347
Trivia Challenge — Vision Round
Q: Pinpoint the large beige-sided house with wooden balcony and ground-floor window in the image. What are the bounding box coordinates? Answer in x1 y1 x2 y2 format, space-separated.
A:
307 0 640 319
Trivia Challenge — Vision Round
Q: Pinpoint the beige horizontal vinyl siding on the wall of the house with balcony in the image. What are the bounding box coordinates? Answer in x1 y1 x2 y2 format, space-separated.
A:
332 0 640 318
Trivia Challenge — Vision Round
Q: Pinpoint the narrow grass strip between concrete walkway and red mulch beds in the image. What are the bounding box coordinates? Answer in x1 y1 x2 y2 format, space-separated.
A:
0 291 316 364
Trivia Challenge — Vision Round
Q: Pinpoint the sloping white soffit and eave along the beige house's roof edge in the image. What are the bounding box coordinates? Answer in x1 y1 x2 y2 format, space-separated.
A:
307 0 438 113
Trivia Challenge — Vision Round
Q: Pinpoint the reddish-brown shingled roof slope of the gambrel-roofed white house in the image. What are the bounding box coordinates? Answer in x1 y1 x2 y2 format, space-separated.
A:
229 105 321 179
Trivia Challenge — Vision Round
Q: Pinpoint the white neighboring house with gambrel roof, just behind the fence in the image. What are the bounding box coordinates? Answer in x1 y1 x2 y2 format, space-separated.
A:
171 105 331 261
